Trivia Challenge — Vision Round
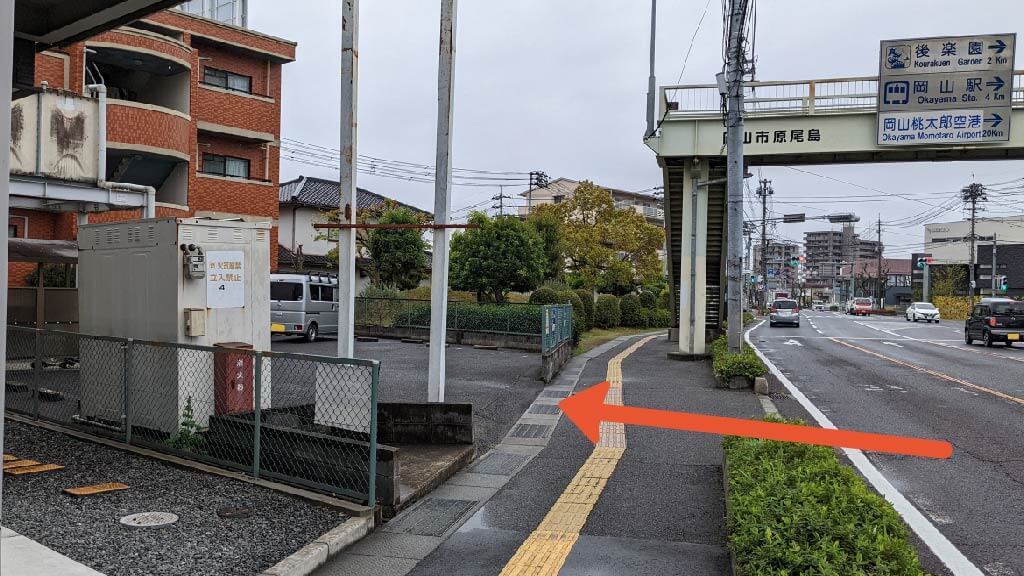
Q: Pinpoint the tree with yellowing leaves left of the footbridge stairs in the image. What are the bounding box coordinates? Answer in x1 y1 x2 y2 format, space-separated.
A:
554 181 665 294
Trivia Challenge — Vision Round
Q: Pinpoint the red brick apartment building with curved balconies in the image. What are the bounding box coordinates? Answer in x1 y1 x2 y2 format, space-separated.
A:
8 0 296 286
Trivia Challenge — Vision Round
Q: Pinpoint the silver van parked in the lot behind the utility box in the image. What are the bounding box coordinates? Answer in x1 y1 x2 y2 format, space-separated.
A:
270 274 338 342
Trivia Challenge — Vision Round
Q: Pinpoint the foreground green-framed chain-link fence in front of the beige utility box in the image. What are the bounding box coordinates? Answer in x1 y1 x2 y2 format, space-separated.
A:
5 327 380 502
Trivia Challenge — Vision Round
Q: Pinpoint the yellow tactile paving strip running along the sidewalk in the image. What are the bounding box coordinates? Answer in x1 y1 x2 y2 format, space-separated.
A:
502 336 657 576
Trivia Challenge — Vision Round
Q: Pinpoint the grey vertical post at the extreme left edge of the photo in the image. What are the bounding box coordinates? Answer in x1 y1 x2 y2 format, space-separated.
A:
0 0 14 515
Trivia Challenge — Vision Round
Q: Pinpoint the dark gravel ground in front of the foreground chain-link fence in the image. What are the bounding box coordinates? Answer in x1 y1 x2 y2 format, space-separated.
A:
3 420 346 576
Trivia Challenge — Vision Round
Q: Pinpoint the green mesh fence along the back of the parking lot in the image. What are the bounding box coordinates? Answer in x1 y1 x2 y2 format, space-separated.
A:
355 298 544 336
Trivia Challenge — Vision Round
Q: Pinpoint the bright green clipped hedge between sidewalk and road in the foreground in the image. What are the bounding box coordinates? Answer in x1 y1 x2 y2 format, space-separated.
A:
724 417 923 576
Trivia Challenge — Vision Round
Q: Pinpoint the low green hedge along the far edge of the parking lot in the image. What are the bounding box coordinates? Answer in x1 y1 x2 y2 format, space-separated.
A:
393 302 543 334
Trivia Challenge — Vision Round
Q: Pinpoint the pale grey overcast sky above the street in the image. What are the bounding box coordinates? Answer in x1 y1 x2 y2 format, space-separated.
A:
250 0 1024 256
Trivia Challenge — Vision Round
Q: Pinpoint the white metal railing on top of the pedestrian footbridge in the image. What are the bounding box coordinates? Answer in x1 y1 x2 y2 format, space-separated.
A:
662 71 1024 119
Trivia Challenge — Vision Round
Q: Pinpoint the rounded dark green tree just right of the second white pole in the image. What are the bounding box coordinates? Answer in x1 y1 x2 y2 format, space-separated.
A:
449 212 546 302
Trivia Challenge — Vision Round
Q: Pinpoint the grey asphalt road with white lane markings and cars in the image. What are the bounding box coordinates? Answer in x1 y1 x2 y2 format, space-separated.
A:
750 312 1024 576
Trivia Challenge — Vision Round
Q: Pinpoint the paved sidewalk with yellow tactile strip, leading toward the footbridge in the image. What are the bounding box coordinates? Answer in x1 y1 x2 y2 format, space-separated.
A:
317 336 763 576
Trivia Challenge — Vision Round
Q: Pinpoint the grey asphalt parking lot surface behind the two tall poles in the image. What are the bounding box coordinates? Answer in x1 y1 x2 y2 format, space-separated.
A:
273 337 544 454
